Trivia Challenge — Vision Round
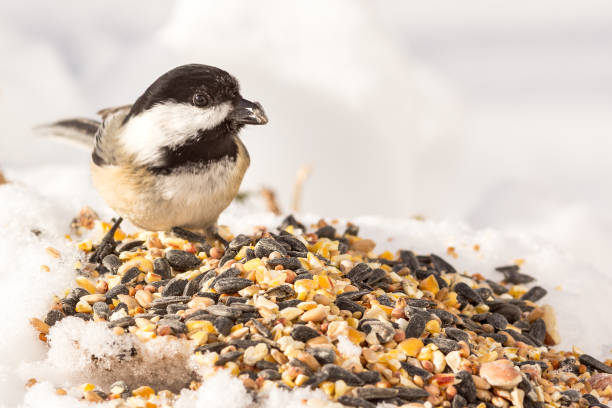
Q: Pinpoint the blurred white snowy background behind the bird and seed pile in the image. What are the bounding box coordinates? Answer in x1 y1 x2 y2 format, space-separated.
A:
0 0 612 273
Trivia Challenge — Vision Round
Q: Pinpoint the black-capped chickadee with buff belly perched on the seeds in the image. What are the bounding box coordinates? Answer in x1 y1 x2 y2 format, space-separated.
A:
37 64 268 242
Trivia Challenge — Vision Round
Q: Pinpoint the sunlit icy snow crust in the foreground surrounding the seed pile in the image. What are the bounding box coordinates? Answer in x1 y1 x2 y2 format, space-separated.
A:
0 171 612 408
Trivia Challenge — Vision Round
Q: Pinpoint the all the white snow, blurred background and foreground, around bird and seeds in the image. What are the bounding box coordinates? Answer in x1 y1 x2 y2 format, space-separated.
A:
0 0 612 407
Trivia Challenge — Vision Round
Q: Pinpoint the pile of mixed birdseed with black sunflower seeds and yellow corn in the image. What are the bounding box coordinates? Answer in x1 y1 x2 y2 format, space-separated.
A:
32 213 612 408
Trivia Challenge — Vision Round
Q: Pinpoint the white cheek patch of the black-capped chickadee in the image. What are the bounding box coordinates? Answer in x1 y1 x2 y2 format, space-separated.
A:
121 102 232 164
